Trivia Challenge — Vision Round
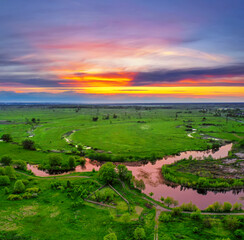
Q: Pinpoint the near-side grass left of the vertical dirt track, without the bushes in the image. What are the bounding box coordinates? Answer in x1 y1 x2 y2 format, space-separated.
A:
0 170 155 240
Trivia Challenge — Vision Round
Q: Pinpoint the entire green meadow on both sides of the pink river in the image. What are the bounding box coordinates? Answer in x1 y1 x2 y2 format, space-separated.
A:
0 105 244 240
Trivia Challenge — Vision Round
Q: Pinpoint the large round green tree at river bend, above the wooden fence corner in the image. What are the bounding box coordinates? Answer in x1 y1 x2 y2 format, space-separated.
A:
98 162 117 183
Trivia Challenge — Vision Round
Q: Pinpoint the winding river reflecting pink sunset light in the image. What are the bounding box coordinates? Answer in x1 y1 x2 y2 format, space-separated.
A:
28 144 244 209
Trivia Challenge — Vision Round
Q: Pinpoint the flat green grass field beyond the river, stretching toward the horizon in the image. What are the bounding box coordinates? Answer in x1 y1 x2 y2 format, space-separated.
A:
0 105 244 163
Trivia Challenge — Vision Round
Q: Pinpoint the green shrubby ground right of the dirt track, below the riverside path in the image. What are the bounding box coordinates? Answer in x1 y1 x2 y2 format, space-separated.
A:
159 213 244 240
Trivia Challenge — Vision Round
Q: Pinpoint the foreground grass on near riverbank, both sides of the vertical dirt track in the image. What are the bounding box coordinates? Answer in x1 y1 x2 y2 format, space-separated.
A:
0 169 244 240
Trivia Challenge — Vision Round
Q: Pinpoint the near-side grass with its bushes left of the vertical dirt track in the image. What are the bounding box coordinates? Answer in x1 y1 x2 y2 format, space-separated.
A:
0 167 155 240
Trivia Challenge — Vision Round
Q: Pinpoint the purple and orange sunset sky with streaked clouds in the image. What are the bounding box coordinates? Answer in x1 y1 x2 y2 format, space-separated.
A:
0 0 244 103
